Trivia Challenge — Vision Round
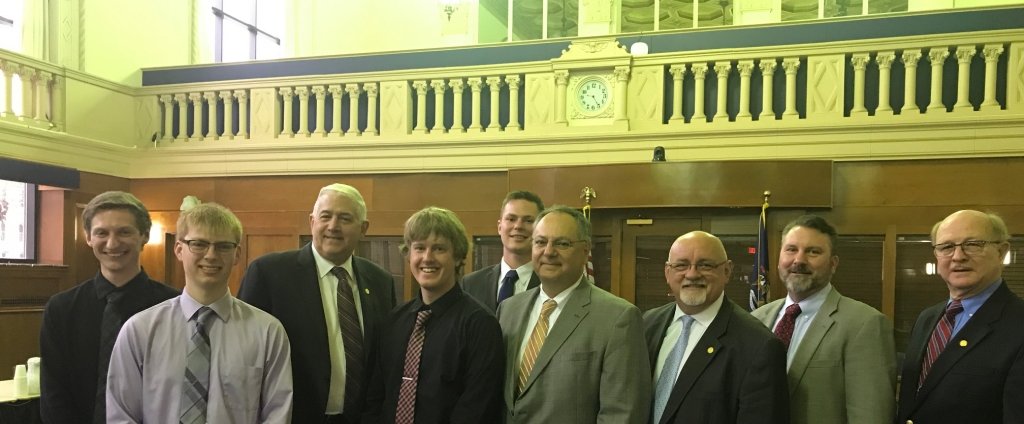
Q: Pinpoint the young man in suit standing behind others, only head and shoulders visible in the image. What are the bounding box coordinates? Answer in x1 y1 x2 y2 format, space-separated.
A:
462 192 544 312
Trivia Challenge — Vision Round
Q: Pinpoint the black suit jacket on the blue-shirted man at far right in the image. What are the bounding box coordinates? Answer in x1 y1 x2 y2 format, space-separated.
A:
896 282 1024 424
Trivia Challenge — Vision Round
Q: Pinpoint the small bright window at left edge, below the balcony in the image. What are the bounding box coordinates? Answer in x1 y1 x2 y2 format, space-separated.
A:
0 179 36 262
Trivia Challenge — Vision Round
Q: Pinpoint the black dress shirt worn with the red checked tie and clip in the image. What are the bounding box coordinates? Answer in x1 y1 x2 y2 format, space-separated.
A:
364 285 505 424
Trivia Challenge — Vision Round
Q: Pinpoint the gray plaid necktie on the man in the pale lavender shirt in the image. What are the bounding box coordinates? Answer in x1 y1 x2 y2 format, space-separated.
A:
180 306 217 424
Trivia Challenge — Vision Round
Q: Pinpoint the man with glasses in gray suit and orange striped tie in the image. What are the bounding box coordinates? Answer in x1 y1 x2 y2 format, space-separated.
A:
498 206 651 424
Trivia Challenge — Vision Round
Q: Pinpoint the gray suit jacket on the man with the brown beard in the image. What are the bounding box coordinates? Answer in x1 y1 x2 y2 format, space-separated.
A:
753 287 896 424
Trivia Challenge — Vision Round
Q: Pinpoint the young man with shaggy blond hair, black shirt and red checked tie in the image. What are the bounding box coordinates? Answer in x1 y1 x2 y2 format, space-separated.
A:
364 207 505 424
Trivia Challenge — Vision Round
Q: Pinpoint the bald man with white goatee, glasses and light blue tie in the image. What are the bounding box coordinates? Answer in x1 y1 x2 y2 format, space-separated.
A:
643 231 790 424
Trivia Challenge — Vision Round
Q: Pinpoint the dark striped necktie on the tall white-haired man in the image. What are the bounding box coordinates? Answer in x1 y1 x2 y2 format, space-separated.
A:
331 266 362 412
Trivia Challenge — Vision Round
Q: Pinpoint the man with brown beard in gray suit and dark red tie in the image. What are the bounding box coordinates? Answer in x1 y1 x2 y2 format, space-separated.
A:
753 215 896 424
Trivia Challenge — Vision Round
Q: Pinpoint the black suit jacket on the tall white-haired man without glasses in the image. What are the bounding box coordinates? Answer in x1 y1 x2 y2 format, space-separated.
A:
239 244 395 423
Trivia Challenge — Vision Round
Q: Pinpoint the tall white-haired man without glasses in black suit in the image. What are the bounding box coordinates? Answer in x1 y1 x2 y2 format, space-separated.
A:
239 183 395 423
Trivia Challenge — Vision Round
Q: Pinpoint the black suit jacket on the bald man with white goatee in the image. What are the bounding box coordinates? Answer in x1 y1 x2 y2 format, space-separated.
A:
643 299 790 424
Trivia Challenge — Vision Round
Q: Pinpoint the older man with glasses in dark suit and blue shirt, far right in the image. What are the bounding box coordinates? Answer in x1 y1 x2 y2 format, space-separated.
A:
896 210 1024 424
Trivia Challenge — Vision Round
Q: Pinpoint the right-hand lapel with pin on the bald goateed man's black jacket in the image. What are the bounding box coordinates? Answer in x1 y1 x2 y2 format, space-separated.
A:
662 299 733 423
